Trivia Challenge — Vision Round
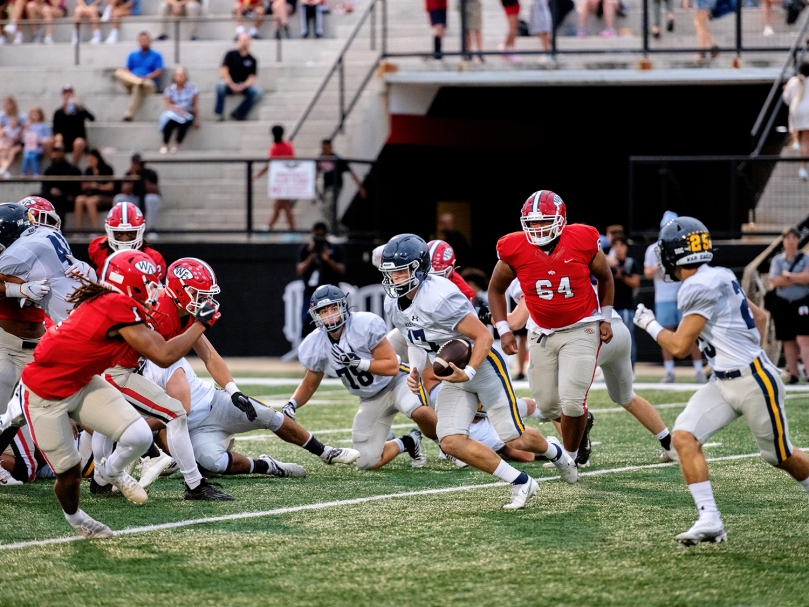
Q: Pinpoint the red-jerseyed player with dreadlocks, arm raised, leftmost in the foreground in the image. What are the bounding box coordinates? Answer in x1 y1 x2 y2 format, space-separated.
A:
22 251 219 538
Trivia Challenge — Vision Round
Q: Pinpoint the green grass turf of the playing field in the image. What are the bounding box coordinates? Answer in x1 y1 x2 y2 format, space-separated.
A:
0 386 809 607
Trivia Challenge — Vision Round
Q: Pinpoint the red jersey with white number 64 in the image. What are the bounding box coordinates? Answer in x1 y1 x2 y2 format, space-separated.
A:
497 223 601 329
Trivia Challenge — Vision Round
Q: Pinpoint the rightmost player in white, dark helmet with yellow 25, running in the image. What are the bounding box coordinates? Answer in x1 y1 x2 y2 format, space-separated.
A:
635 217 809 546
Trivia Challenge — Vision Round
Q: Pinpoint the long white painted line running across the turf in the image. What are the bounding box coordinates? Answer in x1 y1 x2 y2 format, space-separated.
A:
0 453 784 550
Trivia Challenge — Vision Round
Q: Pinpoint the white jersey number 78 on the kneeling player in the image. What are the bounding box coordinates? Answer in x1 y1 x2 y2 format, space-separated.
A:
298 312 393 398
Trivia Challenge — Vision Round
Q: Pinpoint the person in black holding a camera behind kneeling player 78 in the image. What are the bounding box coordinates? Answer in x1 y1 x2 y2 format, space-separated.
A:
295 221 346 337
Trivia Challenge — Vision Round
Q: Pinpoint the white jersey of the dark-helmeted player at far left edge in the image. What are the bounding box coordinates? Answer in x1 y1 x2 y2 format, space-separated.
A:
0 228 95 324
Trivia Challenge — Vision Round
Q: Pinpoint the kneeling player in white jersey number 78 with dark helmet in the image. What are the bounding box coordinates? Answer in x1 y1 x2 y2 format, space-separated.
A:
290 285 437 470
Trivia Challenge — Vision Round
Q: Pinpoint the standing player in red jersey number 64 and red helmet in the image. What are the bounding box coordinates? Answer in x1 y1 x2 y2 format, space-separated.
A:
489 190 614 465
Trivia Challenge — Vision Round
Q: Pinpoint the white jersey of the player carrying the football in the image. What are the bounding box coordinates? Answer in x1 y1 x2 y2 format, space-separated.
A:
385 276 477 362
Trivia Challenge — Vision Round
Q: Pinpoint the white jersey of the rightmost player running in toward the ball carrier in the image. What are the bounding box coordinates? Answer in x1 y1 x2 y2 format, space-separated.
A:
677 265 762 371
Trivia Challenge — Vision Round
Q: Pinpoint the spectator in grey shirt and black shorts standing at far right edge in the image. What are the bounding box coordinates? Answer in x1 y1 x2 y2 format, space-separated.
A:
770 228 809 384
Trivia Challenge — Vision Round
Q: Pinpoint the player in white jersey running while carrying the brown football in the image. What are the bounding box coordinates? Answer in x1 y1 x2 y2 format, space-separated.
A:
379 234 578 510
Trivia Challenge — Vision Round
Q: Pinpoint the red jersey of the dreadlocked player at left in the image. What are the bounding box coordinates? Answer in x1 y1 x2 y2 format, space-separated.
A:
22 293 146 400
